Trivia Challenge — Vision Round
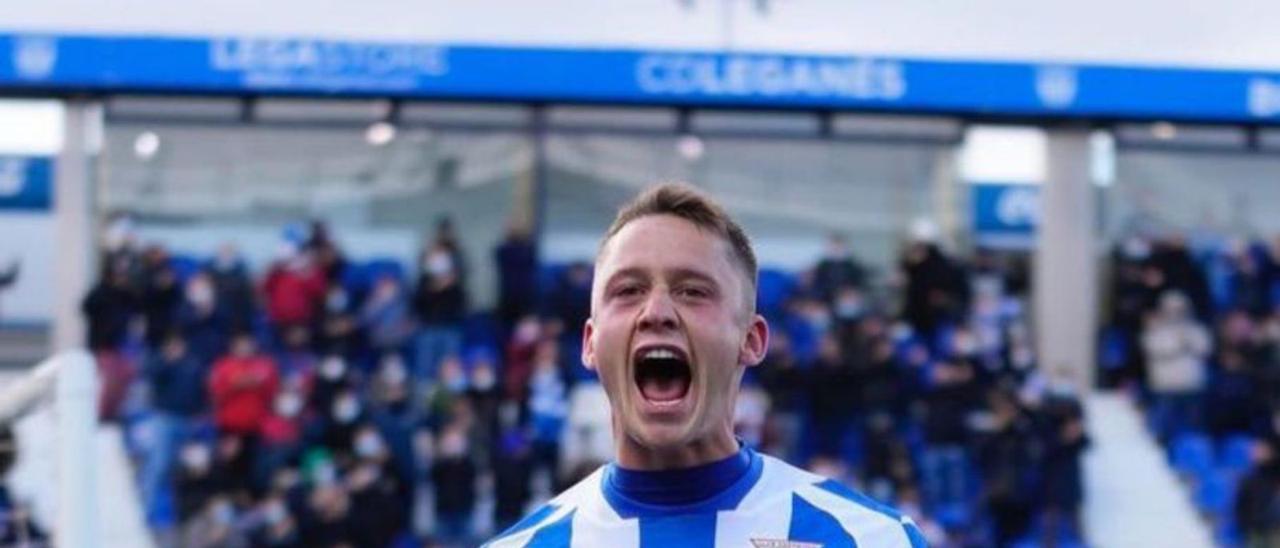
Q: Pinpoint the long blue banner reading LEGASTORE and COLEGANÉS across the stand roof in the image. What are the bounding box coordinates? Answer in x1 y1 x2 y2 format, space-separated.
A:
0 32 1280 123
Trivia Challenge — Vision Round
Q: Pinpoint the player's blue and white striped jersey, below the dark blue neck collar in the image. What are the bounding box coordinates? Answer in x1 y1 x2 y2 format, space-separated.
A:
485 449 925 548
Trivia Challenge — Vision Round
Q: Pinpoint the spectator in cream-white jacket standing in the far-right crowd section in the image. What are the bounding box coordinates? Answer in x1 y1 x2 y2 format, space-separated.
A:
1142 292 1211 440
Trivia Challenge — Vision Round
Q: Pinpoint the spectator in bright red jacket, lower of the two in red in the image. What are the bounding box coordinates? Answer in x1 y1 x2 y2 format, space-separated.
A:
209 333 280 437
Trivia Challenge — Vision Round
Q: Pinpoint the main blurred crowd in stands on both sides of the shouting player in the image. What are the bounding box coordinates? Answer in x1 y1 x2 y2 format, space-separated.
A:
83 219 1090 548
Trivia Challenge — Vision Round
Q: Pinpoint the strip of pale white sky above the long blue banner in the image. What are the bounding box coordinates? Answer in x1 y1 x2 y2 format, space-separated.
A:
0 0 1280 69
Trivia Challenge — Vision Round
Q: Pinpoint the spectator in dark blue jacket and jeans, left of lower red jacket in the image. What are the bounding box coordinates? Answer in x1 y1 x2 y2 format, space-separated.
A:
141 333 207 513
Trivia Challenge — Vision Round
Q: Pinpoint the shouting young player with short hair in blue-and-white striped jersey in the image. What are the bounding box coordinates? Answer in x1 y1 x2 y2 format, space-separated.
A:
488 184 924 548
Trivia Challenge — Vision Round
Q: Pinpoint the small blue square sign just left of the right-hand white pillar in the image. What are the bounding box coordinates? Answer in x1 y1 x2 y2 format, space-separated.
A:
969 183 1041 247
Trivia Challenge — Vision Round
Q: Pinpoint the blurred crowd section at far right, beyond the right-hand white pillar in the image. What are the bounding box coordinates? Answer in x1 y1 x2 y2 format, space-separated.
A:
1100 234 1280 545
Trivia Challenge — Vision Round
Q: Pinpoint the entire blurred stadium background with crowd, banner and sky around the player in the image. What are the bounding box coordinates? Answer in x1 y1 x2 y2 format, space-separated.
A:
0 0 1280 548
